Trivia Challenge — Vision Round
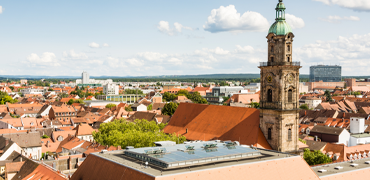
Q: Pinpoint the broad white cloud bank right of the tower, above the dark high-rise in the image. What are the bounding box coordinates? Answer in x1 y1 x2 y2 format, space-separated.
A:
294 33 370 75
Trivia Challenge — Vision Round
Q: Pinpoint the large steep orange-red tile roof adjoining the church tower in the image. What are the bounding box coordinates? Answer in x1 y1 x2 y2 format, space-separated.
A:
164 103 270 149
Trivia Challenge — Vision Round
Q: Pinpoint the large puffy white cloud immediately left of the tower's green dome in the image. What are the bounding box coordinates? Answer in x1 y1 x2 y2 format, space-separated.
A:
203 5 270 33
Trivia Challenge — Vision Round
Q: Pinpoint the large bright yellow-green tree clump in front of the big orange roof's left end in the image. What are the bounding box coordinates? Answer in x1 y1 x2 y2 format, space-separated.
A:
93 119 186 148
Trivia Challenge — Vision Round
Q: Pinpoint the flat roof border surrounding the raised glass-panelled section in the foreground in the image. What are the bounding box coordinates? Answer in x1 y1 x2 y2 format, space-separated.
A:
90 141 297 177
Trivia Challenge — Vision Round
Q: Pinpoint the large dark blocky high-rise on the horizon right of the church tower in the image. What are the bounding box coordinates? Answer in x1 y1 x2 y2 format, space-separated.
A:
310 65 342 82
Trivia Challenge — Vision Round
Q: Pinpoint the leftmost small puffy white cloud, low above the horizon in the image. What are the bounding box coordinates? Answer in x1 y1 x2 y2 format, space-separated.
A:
27 52 60 66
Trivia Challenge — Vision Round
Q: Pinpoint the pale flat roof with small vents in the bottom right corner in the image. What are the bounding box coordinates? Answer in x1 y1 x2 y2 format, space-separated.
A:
312 158 370 178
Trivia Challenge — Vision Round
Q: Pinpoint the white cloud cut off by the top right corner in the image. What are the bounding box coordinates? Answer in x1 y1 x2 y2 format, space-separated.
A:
314 0 370 11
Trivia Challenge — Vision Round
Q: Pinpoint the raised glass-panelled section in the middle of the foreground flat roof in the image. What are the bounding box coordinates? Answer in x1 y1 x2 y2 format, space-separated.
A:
125 141 260 169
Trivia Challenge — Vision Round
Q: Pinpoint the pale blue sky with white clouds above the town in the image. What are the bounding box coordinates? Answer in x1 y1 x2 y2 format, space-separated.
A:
0 0 370 76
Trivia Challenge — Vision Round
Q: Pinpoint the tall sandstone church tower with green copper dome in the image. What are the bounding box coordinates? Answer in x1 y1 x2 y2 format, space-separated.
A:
259 0 301 153
